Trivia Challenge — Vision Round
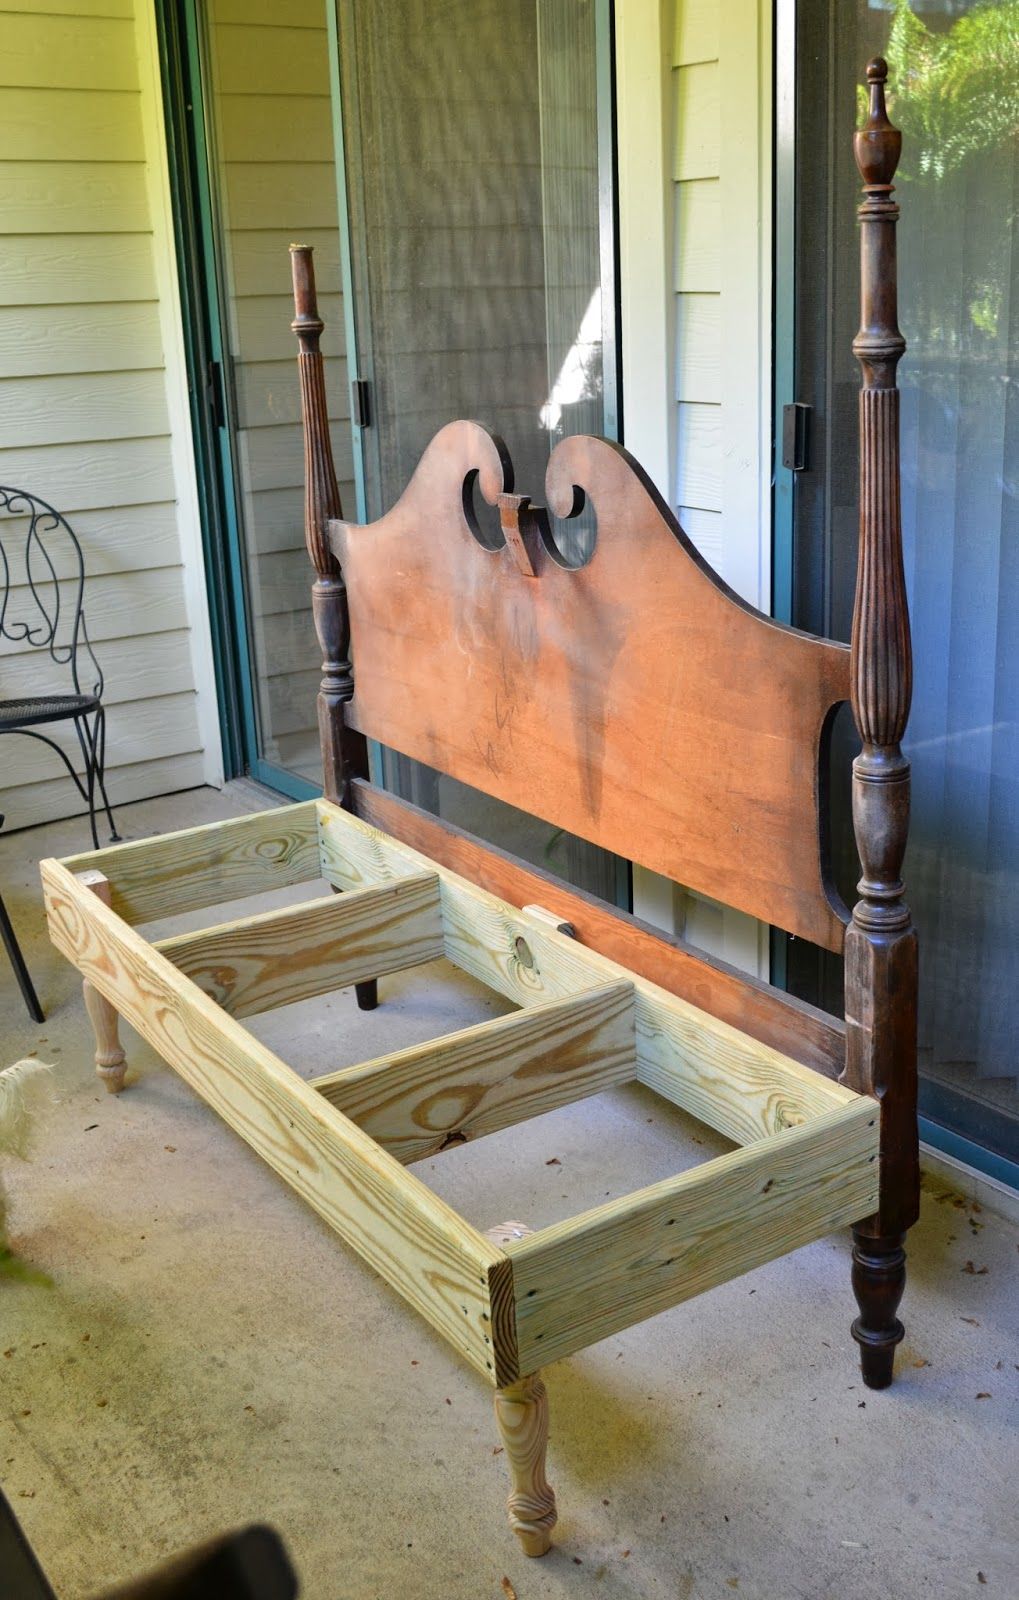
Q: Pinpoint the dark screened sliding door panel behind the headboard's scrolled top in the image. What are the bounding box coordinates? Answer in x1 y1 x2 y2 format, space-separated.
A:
338 0 627 901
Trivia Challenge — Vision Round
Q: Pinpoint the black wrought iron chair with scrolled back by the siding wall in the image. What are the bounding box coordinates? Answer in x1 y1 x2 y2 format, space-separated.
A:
0 486 118 850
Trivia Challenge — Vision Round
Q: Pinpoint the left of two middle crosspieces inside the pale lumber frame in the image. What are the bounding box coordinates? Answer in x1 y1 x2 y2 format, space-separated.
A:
155 872 443 1016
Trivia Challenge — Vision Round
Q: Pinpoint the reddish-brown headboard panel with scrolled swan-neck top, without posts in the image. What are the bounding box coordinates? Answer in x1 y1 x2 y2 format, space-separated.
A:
328 422 849 950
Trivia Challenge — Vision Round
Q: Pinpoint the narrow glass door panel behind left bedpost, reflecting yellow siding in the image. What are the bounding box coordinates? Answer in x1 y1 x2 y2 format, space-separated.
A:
200 0 354 786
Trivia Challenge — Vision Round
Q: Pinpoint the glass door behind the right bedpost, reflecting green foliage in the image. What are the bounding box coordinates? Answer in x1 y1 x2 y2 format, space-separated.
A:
789 0 1019 1162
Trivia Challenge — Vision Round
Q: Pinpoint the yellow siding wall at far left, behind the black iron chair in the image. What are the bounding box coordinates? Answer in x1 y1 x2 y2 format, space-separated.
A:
0 9 208 827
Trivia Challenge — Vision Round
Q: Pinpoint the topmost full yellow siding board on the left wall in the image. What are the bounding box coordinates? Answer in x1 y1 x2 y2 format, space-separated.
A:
0 11 138 90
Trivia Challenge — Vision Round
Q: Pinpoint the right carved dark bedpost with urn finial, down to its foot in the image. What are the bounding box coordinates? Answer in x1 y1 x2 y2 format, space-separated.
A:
845 59 920 1389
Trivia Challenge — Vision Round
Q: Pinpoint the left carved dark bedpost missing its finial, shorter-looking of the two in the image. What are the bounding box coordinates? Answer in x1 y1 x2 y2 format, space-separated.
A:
290 245 379 1011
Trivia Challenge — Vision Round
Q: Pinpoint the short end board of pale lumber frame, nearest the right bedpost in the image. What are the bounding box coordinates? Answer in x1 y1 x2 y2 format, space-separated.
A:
506 1099 878 1373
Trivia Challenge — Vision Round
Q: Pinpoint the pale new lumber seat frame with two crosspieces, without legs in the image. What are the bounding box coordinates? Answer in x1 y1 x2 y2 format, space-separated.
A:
42 802 880 1389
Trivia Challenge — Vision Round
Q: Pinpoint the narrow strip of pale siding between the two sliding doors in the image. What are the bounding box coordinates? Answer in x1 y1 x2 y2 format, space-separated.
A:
672 0 769 608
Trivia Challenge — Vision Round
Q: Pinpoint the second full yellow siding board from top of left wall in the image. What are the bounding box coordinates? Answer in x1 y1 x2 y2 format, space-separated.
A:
3 88 144 162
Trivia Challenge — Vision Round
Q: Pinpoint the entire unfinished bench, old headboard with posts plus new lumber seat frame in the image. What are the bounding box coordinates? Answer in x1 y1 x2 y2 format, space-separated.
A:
42 62 918 1555
